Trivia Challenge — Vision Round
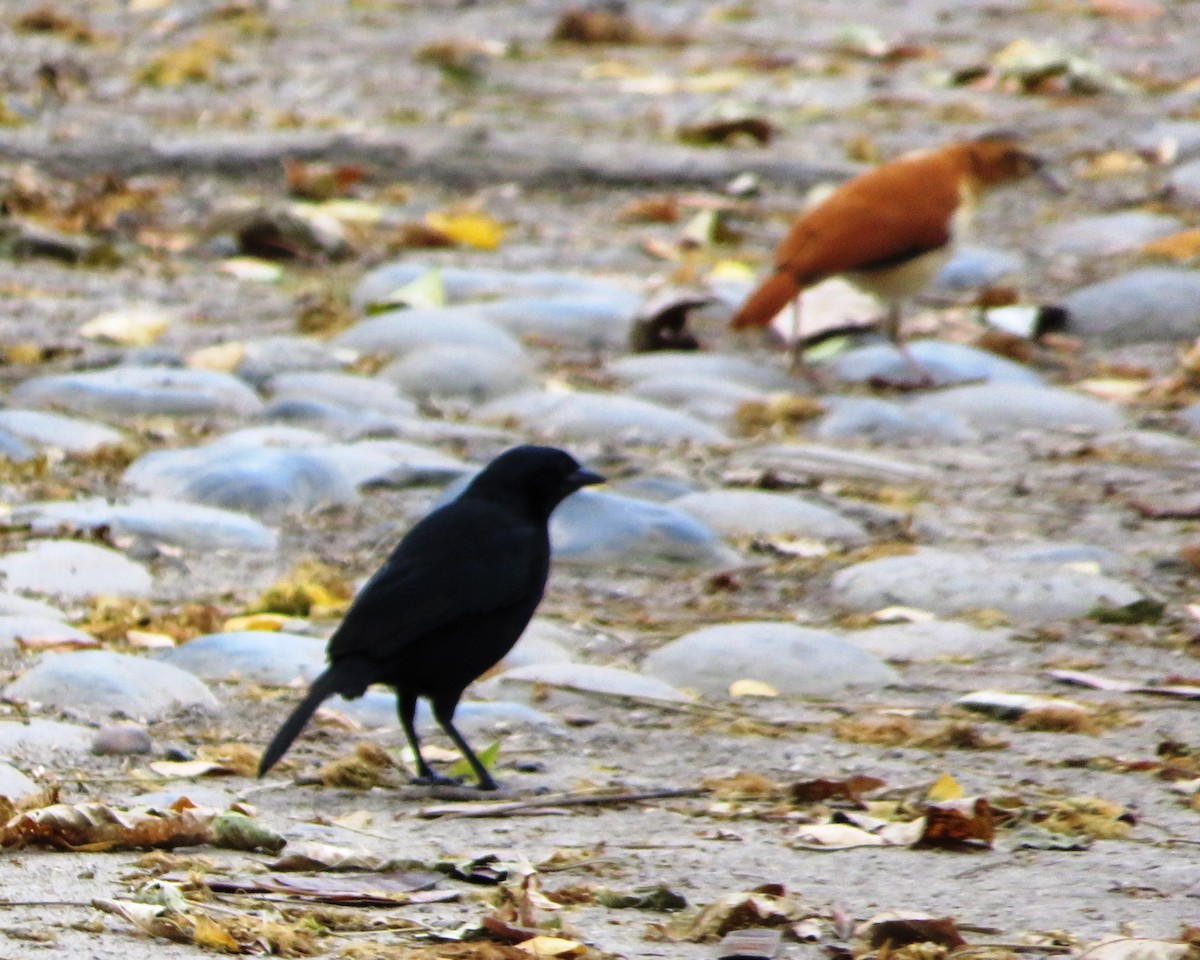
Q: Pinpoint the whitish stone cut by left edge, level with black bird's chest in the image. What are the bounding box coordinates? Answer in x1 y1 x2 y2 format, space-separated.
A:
0 540 154 600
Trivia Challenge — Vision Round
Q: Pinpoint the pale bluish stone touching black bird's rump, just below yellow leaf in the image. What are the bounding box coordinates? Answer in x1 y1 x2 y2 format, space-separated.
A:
158 630 325 686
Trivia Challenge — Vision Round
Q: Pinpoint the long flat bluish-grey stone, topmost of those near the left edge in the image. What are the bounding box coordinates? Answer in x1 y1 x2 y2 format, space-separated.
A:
10 367 263 418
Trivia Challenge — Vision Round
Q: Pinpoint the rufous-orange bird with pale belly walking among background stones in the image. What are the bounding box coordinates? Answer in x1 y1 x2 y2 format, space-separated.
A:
730 133 1061 380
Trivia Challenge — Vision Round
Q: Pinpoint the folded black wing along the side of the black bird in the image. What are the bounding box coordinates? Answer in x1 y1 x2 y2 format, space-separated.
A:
329 499 540 662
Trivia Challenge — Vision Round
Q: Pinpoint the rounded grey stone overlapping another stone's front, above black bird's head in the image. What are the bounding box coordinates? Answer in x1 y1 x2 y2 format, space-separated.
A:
379 343 534 403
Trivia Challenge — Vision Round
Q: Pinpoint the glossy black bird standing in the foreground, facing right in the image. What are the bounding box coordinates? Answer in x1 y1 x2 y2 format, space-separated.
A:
258 446 604 790
